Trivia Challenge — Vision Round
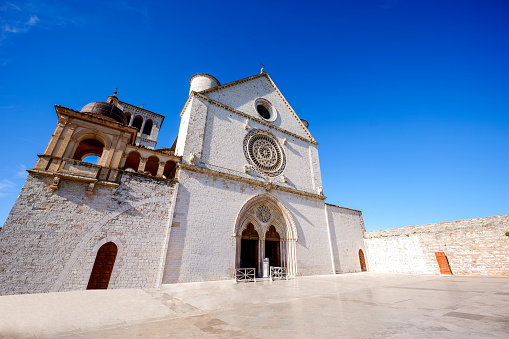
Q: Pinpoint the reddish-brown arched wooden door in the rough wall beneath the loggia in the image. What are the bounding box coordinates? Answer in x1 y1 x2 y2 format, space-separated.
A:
87 241 117 290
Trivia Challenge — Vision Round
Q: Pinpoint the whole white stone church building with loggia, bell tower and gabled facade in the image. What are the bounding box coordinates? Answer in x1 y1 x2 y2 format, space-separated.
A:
0 70 366 294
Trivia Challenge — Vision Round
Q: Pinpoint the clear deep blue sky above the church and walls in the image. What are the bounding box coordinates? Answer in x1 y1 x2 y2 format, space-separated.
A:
0 0 509 230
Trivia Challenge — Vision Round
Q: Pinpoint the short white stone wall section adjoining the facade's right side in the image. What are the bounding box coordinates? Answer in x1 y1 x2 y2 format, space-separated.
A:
326 204 364 273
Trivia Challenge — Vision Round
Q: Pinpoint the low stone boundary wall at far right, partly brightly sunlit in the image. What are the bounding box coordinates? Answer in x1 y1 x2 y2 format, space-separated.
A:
364 215 509 276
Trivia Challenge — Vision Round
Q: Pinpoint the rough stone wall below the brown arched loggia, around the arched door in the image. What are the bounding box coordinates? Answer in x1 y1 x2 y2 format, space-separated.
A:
0 173 174 294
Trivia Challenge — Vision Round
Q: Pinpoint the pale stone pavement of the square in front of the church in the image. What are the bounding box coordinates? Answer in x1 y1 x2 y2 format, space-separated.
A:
0 273 509 339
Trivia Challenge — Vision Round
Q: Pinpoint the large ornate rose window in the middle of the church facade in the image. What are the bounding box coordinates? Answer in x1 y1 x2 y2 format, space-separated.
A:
244 129 286 176
